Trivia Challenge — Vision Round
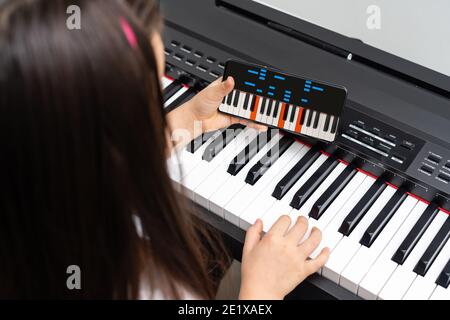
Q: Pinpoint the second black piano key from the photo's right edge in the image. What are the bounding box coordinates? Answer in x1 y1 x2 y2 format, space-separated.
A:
414 217 450 276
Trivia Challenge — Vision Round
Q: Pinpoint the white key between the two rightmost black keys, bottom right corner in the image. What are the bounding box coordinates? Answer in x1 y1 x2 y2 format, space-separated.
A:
403 235 450 300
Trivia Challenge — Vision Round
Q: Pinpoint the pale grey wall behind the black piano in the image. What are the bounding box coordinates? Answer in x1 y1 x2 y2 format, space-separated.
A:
254 0 450 76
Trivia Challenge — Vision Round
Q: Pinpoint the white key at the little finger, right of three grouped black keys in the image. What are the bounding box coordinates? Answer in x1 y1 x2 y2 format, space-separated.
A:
309 172 373 258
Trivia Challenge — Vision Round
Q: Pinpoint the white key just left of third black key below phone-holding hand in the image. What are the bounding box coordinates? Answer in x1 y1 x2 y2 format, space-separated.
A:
194 128 258 208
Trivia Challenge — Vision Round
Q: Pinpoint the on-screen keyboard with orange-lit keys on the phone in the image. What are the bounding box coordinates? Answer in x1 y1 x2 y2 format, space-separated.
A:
219 90 339 141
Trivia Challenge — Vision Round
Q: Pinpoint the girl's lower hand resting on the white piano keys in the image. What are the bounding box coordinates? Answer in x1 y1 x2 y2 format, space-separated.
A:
239 216 330 300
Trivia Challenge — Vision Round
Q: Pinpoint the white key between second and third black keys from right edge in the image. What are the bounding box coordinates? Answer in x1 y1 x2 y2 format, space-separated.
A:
378 212 447 300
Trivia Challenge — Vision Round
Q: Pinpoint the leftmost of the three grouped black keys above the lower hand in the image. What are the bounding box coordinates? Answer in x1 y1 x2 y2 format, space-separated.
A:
272 146 320 200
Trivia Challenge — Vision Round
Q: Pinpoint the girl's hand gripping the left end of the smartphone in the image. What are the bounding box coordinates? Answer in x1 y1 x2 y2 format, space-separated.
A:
188 77 266 132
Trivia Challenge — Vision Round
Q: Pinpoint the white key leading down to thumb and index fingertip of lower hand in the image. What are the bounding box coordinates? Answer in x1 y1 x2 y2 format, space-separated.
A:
262 152 327 232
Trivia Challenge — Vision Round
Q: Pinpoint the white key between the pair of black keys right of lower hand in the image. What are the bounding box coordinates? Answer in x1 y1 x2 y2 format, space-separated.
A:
323 182 395 283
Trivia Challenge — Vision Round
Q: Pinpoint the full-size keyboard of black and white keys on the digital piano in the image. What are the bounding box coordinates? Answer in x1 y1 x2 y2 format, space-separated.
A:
162 74 450 300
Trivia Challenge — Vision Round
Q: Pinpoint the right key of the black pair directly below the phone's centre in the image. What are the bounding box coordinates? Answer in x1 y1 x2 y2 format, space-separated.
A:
245 136 294 185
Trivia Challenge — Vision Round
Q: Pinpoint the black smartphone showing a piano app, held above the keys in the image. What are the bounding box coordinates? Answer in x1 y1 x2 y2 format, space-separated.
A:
219 60 347 141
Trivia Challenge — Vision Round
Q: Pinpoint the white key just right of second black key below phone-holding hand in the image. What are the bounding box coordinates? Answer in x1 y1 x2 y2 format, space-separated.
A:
182 128 253 199
